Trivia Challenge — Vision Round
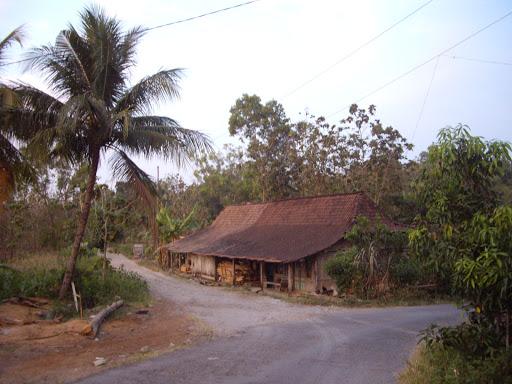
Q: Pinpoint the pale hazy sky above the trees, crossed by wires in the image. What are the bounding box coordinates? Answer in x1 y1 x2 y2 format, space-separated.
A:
0 0 512 183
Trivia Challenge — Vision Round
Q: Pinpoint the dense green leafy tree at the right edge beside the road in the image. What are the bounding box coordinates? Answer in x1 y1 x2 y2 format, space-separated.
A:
409 126 512 382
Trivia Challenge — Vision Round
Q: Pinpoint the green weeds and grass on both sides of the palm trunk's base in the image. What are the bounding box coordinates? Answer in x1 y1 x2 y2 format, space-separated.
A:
0 252 150 317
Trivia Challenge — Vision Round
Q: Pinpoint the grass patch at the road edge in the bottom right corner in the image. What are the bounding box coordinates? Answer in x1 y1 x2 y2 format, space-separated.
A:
398 344 512 384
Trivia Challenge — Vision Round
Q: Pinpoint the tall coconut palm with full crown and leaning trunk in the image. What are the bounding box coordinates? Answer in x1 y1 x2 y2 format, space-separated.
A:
9 7 211 299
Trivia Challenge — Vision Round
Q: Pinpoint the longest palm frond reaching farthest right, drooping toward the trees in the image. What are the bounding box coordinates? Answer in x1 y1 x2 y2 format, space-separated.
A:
115 116 212 165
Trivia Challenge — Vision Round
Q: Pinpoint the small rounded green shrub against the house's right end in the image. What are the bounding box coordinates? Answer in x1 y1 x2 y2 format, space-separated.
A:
325 248 360 292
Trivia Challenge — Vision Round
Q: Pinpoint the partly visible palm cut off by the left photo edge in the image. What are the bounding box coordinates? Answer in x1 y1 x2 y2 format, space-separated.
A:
0 27 32 207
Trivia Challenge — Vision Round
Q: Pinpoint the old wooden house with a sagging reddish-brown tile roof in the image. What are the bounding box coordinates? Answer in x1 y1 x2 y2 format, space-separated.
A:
167 193 398 293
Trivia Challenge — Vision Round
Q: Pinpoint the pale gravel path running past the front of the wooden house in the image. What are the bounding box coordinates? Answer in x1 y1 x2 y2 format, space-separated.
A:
108 254 330 335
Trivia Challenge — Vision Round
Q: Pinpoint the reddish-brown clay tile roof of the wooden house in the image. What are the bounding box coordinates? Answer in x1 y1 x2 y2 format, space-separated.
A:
167 193 398 262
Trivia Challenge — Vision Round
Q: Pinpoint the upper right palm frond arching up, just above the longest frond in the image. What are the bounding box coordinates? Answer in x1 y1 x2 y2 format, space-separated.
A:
115 68 182 115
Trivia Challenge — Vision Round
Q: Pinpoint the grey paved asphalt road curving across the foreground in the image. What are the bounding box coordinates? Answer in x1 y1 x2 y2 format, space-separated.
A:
75 255 462 384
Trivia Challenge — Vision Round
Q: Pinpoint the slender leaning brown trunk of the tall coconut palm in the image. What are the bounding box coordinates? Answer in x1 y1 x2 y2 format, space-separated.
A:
59 149 100 300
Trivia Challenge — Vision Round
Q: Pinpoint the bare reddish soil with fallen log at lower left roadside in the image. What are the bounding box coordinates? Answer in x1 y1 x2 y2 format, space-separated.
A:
0 301 204 384
